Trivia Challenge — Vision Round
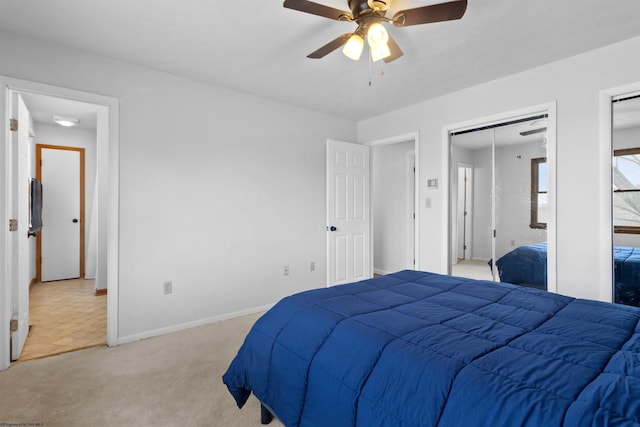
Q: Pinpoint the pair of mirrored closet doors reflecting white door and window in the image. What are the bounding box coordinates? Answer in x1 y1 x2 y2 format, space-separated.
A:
449 114 548 289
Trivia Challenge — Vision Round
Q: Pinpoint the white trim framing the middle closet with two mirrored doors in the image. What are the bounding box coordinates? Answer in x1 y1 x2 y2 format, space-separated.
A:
441 101 558 292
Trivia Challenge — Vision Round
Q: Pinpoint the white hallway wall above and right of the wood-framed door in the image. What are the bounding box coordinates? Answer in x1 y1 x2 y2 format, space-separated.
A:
34 122 97 278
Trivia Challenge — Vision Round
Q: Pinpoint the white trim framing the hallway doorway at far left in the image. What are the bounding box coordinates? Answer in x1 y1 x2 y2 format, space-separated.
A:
0 76 120 370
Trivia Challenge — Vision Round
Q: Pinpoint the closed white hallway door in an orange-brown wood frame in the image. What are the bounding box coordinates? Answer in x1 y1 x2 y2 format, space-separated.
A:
41 148 81 282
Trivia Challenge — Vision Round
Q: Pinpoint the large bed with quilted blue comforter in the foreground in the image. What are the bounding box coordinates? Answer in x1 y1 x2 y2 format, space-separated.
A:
222 271 640 427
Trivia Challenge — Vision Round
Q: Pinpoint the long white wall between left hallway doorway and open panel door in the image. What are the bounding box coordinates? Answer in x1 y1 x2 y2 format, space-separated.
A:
0 34 357 342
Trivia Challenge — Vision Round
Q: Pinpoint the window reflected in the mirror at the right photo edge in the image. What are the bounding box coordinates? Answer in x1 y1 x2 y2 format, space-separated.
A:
612 148 640 234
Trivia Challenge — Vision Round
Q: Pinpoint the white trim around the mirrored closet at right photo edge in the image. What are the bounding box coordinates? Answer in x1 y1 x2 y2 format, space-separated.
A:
598 82 640 302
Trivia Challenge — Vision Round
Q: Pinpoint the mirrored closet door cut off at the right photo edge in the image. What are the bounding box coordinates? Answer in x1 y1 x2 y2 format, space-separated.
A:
612 93 640 307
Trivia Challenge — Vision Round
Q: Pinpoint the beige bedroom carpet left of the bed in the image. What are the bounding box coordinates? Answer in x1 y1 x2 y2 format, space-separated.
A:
0 315 282 427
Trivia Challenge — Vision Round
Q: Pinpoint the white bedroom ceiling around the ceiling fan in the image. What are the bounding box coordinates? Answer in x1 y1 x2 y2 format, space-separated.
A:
0 0 640 120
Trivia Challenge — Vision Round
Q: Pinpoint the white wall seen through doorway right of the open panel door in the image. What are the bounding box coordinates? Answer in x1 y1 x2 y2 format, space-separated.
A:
371 141 414 274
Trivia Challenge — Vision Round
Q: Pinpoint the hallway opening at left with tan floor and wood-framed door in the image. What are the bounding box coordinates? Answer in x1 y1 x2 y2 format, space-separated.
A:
18 103 100 361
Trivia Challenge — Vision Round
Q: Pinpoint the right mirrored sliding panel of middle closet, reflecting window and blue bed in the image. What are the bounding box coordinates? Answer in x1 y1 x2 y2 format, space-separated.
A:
493 120 548 290
